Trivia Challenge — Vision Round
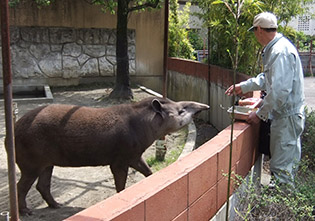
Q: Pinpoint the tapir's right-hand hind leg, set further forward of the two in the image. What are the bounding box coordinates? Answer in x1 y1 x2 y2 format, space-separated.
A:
36 166 61 208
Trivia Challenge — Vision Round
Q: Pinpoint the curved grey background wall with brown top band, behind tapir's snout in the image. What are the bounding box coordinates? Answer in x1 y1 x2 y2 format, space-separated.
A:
167 58 252 131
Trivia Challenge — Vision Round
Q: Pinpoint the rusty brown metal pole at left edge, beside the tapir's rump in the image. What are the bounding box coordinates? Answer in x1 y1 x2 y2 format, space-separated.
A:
0 0 19 221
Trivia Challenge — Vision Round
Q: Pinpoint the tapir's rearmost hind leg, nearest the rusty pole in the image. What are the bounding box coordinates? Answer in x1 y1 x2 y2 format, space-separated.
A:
17 170 38 215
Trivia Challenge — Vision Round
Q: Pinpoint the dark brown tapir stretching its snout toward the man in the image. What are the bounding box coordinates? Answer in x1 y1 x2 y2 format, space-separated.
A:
15 97 209 214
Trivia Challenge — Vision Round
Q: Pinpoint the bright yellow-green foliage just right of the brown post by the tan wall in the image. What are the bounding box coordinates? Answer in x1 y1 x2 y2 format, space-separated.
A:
168 0 195 59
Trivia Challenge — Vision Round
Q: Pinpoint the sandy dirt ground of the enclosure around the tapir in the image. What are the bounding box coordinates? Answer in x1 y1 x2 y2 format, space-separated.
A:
0 86 216 221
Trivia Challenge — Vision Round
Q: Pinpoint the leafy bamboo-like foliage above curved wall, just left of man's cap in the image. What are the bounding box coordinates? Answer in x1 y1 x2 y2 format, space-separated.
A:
195 0 263 72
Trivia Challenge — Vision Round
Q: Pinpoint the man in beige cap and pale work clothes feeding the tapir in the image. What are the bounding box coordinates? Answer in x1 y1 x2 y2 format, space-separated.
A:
225 12 305 186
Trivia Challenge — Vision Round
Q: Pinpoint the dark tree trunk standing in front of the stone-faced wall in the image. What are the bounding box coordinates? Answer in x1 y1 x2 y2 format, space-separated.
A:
109 0 133 99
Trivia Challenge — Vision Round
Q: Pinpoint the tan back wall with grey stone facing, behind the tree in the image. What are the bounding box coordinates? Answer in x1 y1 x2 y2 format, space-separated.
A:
0 0 164 92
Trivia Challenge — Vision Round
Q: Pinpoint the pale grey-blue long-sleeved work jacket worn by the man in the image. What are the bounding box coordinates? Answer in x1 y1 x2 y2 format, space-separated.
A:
241 33 304 120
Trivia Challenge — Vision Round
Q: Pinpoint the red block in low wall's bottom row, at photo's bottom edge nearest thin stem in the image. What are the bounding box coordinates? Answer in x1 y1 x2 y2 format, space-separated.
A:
188 185 217 221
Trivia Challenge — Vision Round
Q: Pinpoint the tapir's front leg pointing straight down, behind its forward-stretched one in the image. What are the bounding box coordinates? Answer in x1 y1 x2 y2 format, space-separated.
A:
110 163 128 193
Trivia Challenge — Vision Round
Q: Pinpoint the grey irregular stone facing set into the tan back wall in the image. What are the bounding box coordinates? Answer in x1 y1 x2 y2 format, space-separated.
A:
0 27 136 79
